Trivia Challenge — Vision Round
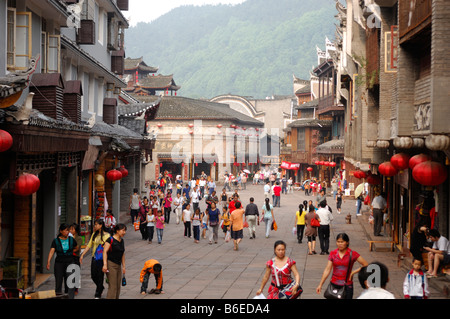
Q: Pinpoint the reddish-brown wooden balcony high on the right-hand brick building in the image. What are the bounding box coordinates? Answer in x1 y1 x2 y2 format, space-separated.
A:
398 0 432 42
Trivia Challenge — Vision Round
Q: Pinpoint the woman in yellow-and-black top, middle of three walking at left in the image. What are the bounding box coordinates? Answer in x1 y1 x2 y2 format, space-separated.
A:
80 219 110 299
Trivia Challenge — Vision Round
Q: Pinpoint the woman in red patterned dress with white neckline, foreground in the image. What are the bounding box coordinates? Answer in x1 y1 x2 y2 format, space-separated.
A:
256 240 302 299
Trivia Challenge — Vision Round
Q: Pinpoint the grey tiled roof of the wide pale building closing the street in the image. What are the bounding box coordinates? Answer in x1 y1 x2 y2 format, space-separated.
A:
155 96 264 127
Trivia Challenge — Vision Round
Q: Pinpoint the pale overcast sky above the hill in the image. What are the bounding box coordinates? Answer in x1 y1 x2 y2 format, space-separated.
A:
123 0 245 26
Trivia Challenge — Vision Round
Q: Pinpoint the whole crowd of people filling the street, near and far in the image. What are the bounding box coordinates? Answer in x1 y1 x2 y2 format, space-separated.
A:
47 171 450 299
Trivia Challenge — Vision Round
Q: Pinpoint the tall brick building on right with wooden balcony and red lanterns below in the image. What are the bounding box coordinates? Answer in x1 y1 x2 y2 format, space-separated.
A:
335 0 450 262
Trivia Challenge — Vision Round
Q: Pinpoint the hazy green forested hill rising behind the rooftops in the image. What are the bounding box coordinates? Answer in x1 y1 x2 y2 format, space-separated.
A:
125 0 336 99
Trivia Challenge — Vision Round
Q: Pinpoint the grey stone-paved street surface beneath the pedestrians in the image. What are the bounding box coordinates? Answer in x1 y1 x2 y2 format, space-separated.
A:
38 185 442 299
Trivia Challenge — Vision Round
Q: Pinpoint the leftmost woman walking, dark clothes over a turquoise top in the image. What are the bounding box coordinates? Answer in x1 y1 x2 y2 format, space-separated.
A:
47 224 77 299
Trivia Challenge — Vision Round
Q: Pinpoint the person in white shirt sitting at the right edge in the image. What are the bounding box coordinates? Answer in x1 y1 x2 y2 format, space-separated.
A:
424 229 450 278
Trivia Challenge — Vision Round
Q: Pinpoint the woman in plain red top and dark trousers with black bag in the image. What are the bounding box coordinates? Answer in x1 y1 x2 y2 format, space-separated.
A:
316 233 368 299
